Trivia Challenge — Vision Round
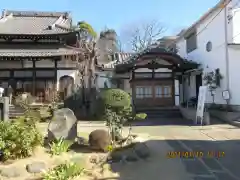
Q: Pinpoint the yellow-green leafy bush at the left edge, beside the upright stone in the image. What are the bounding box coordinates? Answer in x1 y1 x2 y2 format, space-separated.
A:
0 117 43 160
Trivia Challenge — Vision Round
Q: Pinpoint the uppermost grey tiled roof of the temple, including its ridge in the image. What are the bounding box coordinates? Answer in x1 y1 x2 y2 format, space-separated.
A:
0 10 72 35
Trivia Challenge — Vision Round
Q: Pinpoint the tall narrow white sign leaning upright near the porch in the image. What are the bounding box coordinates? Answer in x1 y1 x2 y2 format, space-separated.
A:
196 86 208 125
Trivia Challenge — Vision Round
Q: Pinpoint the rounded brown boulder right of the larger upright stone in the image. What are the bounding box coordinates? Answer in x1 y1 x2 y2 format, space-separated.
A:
88 129 111 152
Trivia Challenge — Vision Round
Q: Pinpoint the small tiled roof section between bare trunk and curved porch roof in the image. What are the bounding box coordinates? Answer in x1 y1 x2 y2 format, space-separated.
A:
103 53 133 69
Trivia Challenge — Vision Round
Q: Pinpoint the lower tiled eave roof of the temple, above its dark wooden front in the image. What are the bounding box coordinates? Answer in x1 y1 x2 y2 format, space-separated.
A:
0 45 79 57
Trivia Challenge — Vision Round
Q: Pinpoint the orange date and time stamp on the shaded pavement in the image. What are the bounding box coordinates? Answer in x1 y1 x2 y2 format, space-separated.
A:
167 151 225 158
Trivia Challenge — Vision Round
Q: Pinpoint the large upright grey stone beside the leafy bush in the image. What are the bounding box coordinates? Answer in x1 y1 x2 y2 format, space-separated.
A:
48 108 77 141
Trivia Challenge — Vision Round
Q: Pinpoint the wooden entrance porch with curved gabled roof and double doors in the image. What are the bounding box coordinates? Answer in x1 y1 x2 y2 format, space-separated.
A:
115 48 198 108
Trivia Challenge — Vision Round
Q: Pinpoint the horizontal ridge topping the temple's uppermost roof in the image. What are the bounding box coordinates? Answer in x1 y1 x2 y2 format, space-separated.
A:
2 10 70 18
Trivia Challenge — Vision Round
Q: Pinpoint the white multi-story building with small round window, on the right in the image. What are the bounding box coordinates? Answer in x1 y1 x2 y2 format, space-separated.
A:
176 0 240 108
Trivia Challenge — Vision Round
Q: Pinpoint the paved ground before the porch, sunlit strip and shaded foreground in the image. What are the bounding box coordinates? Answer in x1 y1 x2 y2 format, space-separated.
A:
76 119 240 180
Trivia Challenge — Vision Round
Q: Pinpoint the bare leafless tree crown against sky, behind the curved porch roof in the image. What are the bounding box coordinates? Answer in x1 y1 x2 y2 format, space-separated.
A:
121 20 166 52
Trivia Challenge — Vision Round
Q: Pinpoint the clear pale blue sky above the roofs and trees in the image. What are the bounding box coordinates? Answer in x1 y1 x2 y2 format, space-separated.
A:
0 0 219 35
